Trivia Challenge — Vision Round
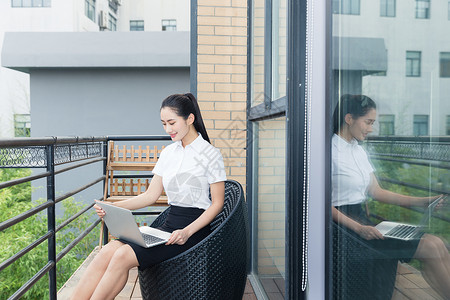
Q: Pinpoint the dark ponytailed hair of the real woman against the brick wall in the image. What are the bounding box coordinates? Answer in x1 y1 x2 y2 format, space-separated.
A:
161 93 211 144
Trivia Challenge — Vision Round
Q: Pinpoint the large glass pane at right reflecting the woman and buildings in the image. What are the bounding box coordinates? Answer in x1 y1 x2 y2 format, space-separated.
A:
325 0 450 299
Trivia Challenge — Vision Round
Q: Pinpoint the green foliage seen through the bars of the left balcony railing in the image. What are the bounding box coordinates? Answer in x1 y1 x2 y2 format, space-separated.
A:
0 169 99 300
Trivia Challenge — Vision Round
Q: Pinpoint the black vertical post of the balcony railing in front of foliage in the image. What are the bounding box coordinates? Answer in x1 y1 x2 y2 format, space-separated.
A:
46 144 57 300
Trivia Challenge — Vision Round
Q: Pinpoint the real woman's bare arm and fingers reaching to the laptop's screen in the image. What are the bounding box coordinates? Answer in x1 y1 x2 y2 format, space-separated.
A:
94 174 163 217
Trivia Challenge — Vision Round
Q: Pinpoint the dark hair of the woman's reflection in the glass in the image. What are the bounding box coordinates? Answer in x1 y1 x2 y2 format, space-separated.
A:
333 94 377 133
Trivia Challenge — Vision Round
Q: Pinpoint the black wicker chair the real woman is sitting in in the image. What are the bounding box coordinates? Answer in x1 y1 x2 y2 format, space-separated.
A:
139 180 248 300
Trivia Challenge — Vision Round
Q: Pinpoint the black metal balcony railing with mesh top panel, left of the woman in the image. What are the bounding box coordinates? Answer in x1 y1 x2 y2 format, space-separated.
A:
0 136 170 299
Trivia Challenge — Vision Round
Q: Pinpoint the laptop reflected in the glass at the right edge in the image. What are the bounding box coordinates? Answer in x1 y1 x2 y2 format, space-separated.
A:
375 195 447 241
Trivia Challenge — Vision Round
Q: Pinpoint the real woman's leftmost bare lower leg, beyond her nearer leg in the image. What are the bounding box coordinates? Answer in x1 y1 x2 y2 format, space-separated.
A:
72 241 123 300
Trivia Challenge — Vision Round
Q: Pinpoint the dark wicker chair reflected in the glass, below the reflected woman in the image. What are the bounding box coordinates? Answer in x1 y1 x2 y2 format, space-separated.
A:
333 222 398 300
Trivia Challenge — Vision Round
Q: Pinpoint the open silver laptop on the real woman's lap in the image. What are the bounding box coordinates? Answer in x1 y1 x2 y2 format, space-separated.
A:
97 201 171 248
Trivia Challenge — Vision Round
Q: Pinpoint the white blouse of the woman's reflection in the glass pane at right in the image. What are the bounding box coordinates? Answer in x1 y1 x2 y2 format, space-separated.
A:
331 134 374 206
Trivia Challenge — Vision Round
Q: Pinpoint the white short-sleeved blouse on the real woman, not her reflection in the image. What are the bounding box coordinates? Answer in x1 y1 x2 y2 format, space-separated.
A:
153 133 227 209
